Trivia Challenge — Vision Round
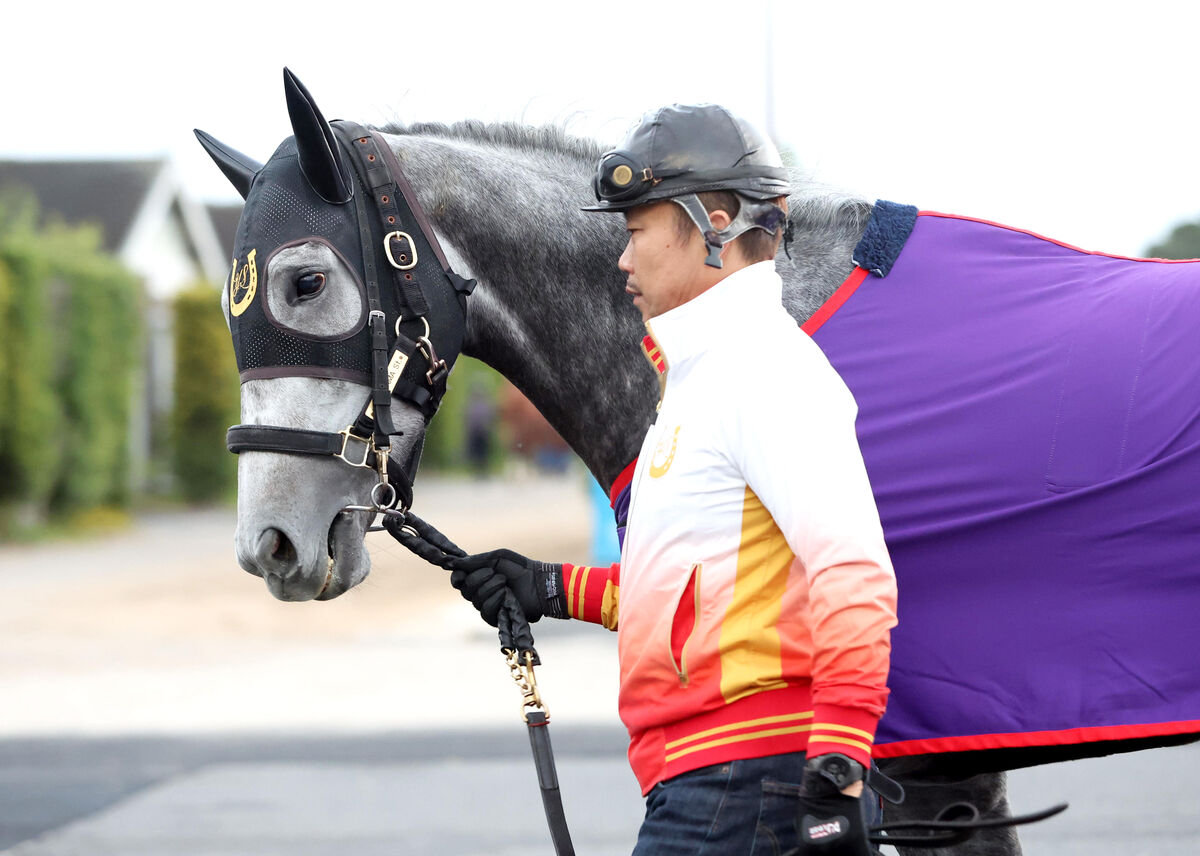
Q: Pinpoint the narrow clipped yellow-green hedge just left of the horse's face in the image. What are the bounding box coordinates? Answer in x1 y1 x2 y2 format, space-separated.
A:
172 283 238 502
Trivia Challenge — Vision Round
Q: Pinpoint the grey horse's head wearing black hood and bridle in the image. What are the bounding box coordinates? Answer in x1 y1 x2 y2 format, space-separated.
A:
197 70 472 600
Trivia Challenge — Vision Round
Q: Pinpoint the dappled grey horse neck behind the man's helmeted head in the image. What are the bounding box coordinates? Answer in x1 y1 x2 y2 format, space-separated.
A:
379 128 870 487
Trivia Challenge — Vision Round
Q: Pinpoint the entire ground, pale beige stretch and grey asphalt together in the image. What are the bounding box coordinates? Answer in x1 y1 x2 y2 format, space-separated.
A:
0 470 1200 856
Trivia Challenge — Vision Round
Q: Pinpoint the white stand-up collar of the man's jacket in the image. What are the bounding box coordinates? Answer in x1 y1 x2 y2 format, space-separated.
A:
642 262 784 375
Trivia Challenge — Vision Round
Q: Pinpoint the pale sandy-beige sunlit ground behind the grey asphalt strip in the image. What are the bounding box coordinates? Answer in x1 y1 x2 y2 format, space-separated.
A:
0 477 616 737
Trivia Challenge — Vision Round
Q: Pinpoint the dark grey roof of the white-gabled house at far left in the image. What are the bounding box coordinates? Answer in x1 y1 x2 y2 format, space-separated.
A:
0 160 166 252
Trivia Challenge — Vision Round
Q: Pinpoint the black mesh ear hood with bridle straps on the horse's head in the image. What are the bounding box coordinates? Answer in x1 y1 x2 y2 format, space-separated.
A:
196 68 475 510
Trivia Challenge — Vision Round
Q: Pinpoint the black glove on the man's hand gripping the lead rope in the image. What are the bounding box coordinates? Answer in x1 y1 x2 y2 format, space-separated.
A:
446 550 571 627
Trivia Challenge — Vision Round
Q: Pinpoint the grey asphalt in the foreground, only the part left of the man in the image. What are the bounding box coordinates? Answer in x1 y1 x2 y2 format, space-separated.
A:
0 724 641 856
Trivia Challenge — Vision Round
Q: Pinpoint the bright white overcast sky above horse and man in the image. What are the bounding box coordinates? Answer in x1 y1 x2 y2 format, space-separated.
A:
0 0 1200 255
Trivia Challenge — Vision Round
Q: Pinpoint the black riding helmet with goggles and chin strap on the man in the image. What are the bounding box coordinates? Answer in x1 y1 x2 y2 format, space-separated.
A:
583 104 791 268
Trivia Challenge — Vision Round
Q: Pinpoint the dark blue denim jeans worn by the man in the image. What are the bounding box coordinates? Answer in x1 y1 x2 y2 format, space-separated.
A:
634 752 880 856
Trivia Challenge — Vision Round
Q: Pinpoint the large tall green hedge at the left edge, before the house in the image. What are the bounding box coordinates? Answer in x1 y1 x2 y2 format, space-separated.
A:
0 193 140 532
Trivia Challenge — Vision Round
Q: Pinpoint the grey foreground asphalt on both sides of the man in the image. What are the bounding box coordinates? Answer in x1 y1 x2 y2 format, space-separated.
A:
0 722 1200 856
